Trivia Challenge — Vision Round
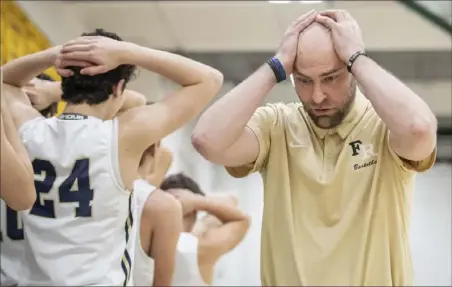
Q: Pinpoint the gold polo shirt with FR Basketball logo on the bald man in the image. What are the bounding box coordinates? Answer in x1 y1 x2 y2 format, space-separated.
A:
227 92 436 286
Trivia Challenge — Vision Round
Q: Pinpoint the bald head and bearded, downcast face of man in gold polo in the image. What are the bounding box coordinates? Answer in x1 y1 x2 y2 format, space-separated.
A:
293 22 356 129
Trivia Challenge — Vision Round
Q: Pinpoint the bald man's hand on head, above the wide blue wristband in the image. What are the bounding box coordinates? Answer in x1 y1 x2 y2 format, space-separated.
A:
275 10 317 76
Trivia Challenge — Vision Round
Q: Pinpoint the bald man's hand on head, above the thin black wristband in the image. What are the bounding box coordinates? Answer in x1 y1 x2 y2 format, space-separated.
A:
316 10 364 63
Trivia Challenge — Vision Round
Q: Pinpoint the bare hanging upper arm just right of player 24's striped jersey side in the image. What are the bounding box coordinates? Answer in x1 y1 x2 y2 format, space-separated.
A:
143 189 182 286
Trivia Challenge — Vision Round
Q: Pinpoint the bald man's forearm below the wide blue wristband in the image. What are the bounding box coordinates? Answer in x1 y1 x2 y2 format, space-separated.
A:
192 64 276 152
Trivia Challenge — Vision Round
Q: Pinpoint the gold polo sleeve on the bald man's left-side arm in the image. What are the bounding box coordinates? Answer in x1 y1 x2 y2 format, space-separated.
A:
225 104 278 178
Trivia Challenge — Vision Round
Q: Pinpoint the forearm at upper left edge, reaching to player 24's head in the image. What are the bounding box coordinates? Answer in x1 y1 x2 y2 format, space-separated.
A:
1 47 58 87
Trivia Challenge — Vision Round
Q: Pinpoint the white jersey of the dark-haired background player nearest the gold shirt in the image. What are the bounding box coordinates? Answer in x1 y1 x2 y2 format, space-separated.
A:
173 232 207 286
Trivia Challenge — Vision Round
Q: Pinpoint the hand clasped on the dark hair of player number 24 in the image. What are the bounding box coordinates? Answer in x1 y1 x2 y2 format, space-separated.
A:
56 36 125 76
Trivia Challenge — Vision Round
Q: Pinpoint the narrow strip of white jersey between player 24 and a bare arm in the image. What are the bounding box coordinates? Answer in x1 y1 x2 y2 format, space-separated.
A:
133 179 155 286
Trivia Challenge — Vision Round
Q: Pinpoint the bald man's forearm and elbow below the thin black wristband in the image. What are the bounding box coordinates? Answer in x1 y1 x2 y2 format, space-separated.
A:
352 57 437 162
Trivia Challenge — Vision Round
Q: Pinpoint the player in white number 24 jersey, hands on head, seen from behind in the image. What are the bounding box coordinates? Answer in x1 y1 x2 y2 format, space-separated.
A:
2 27 222 286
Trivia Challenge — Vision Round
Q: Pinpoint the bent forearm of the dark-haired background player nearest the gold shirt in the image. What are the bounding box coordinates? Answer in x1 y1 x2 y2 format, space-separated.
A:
195 196 248 223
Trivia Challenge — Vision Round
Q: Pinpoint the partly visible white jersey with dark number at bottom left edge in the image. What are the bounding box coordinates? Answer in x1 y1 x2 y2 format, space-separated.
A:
0 200 24 286
